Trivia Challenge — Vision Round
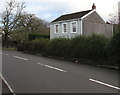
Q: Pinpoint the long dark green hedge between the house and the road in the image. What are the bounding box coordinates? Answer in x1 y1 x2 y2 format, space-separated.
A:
18 34 107 60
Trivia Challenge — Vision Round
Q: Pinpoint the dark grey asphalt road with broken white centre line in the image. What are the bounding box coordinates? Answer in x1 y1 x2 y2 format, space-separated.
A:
2 50 120 95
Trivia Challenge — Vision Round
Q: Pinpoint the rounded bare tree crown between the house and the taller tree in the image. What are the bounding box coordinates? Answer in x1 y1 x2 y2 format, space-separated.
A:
15 13 49 34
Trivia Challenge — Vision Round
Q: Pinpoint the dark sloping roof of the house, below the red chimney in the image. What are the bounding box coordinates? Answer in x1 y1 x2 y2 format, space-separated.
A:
52 10 92 22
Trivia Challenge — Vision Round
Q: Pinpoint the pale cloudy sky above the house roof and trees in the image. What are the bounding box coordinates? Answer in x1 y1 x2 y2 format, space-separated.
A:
0 0 120 22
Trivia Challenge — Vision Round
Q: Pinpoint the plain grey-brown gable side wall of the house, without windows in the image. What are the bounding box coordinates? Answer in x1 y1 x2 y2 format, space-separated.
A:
83 12 113 38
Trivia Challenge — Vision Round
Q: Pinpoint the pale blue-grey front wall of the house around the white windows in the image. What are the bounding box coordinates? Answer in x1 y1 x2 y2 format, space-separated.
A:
50 19 82 39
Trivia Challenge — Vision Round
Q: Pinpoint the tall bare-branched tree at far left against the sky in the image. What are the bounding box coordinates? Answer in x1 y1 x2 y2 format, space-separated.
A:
1 0 25 47
